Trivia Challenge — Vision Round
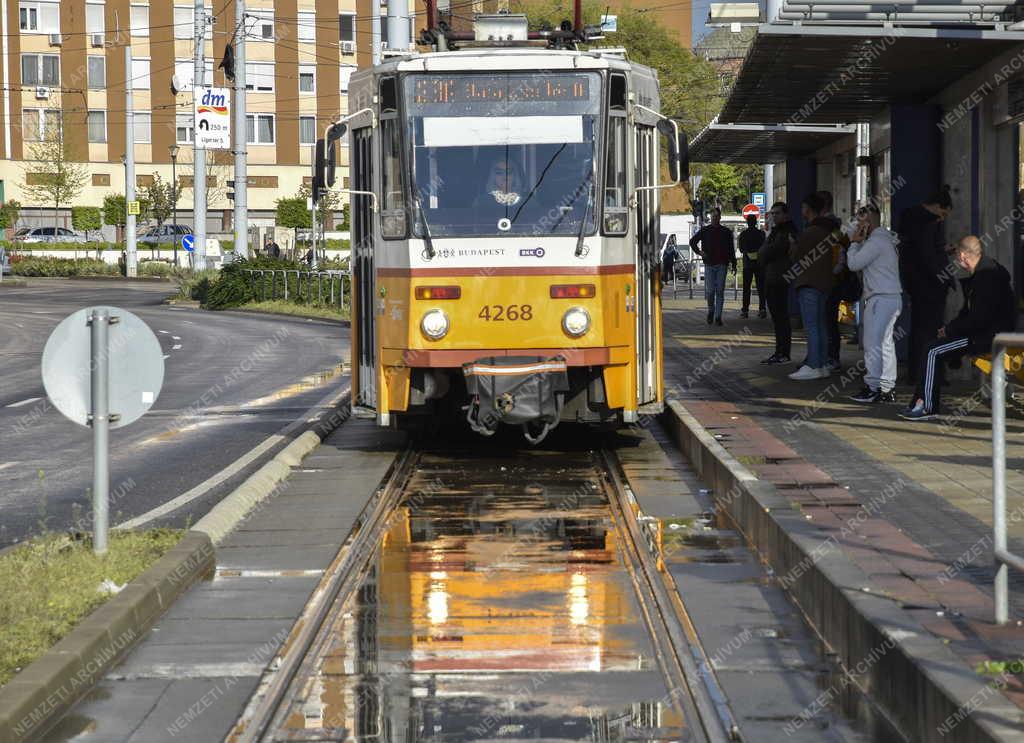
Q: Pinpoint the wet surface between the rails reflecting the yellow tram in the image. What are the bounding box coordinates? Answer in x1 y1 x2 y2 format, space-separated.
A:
276 450 692 742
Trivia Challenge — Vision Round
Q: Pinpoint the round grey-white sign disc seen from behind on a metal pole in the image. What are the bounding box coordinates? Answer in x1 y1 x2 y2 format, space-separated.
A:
43 307 164 428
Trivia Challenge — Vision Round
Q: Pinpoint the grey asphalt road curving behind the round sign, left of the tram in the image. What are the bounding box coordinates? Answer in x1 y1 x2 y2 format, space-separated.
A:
0 279 348 545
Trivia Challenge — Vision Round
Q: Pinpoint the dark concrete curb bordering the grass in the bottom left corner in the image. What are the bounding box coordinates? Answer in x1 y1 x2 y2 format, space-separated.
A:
0 530 215 743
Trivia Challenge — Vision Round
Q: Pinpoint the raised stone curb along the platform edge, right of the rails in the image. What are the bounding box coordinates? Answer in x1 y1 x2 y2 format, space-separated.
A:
664 400 1024 743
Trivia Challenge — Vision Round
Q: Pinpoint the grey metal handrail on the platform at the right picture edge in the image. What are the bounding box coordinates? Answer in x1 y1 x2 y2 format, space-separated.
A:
992 333 1024 624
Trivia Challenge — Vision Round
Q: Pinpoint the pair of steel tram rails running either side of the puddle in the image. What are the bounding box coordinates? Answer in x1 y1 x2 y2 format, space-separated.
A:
232 445 740 743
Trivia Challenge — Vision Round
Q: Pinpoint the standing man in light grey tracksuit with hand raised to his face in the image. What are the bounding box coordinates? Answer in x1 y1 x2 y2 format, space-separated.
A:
847 204 902 402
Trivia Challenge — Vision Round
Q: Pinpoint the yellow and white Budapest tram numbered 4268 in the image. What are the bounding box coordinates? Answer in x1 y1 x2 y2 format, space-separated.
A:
319 7 686 448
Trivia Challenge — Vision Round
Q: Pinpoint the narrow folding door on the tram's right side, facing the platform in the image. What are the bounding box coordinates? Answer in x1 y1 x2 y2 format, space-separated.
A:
635 124 658 405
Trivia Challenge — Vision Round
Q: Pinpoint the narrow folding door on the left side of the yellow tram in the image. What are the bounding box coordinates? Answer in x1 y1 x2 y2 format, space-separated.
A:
351 127 377 411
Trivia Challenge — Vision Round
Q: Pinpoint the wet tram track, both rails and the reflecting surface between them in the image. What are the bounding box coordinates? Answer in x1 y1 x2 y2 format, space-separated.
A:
228 439 736 741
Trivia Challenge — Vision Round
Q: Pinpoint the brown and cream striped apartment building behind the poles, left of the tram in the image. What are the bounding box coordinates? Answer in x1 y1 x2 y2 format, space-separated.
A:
0 0 358 232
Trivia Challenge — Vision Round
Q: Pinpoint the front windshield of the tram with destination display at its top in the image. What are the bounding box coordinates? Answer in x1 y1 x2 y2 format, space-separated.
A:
406 73 600 237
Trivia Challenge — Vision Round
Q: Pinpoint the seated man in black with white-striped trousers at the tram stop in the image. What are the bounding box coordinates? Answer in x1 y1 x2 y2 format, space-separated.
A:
900 235 1017 421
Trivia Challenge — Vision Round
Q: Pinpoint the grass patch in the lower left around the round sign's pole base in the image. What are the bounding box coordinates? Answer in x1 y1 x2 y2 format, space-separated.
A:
0 529 184 685
